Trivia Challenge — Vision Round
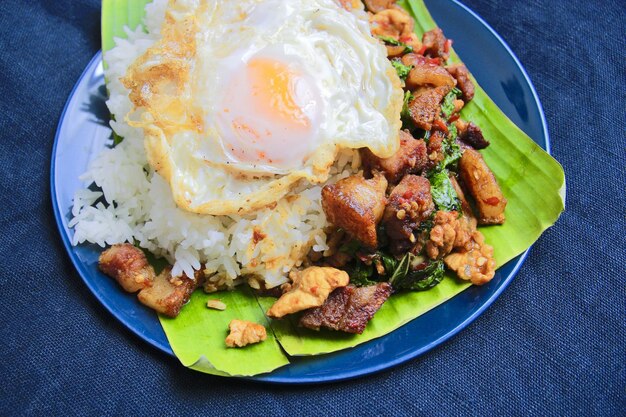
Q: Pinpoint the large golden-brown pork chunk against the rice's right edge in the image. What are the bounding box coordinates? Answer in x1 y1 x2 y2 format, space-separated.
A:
322 174 387 249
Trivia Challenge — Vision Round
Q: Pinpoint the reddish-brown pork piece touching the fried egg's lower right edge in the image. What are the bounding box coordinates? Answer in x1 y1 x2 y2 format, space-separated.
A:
361 130 428 184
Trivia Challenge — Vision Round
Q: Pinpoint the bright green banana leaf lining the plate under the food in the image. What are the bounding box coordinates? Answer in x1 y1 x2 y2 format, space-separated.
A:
102 0 565 375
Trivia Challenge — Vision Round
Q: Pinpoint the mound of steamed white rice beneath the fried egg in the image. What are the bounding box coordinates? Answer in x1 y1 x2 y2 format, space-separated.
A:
70 0 360 287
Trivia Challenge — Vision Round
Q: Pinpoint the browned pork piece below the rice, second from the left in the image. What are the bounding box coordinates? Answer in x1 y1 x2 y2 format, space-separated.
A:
137 266 204 317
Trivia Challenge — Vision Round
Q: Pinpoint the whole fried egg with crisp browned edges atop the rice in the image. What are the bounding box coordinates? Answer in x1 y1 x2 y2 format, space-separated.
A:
122 0 402 215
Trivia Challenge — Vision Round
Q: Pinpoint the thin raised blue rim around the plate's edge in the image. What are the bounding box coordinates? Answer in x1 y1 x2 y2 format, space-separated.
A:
50 0 551 385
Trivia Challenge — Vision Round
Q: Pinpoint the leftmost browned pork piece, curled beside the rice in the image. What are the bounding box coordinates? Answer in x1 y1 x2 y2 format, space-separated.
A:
98 243 155 292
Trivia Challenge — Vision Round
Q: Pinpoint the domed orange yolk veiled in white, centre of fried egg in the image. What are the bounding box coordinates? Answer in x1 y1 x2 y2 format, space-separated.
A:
218 57 320 168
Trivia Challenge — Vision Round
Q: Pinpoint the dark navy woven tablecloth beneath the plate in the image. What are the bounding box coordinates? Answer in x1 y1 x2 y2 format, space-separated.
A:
0 0 626 416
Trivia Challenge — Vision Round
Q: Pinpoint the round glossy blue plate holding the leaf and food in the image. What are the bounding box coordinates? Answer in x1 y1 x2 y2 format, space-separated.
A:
51 0 549 383
